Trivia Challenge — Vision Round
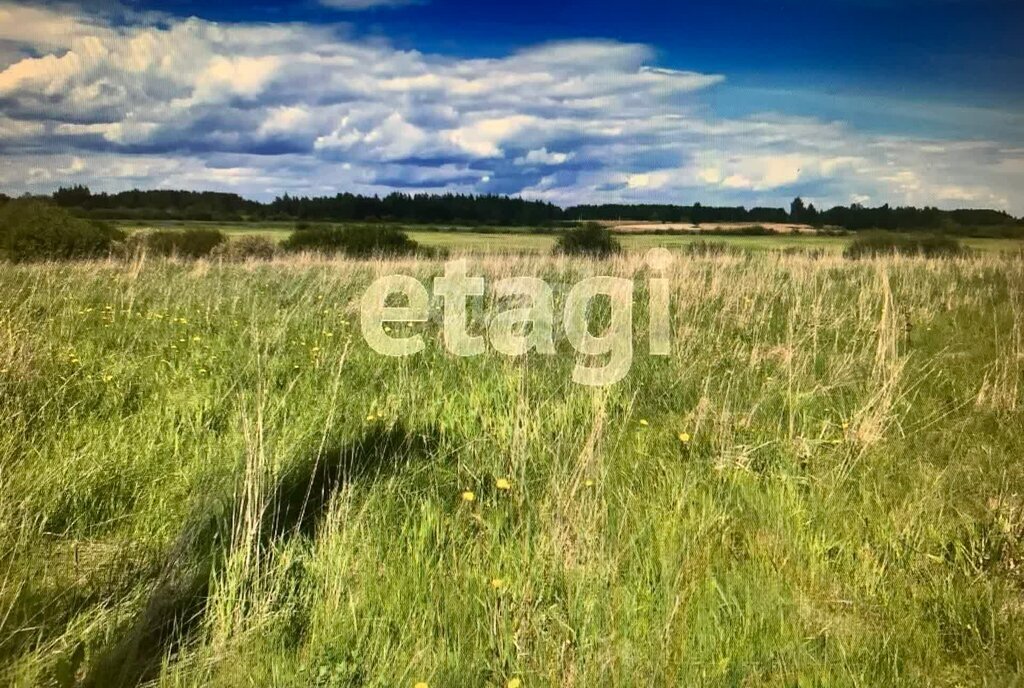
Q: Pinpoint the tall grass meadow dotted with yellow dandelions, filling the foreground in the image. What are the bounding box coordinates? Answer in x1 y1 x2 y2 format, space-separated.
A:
0 249 1024 688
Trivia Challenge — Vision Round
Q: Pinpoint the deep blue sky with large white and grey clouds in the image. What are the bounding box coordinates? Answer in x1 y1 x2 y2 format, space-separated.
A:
0 0 1024 215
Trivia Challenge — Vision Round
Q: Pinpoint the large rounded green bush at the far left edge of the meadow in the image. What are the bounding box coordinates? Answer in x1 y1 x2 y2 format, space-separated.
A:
0 200 125 262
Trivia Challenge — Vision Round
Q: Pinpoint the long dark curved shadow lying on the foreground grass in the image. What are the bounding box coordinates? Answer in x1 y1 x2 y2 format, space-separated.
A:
78 425 437 688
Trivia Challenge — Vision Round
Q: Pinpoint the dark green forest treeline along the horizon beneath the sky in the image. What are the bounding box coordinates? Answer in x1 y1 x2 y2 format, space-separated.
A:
0 185 1024 235
